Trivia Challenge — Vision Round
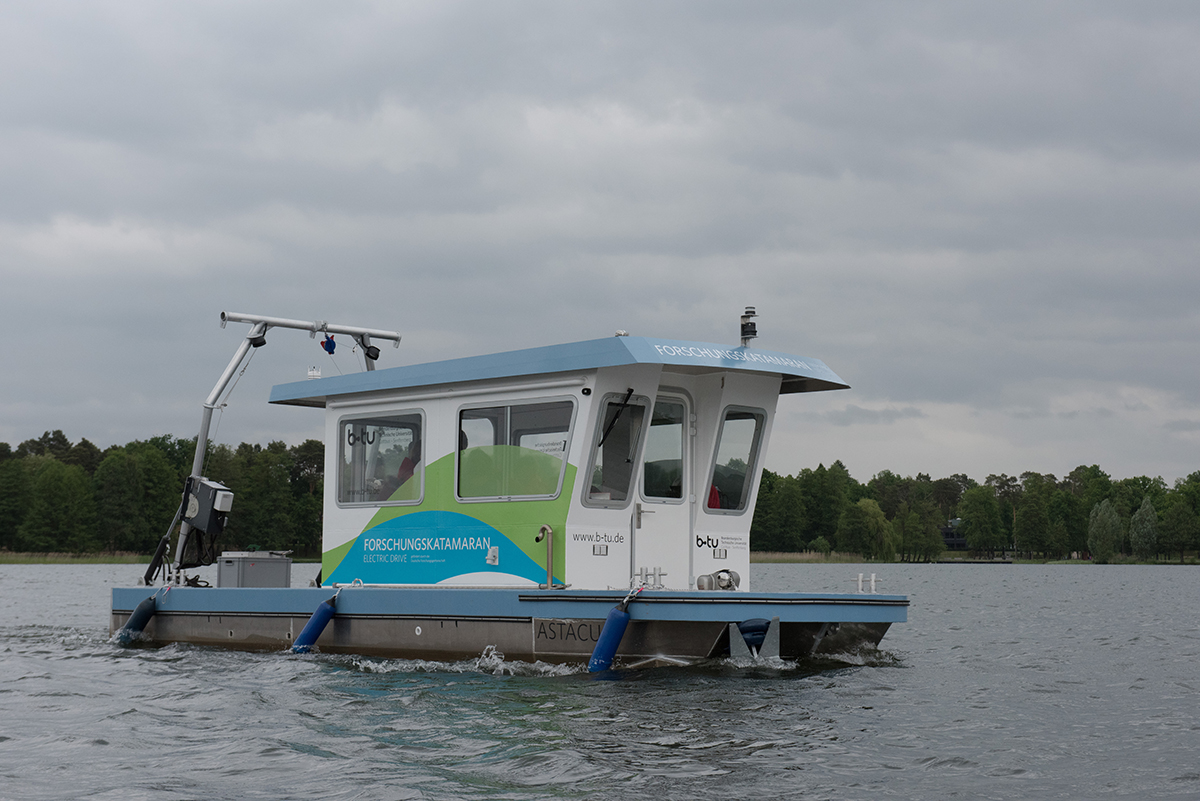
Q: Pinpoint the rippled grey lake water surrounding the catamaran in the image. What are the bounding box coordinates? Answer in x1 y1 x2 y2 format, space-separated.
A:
0 565 1200 801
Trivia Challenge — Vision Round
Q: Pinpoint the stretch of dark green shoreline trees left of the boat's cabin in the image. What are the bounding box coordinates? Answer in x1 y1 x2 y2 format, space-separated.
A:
0 430 325 556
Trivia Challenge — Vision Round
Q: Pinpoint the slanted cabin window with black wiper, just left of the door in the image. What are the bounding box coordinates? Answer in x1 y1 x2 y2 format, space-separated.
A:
583 390 646 506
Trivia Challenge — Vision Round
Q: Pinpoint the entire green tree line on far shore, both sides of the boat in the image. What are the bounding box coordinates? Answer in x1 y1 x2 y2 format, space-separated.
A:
0 430 1200 561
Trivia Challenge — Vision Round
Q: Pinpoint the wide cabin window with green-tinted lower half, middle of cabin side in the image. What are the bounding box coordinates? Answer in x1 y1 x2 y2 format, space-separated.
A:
458 401 575 499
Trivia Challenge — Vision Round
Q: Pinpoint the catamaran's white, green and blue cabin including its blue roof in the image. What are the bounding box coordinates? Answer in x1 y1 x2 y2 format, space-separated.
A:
271 336 846 591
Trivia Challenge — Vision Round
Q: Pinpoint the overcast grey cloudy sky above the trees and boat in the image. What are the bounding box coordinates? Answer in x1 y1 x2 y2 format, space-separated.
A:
0 0 1200 482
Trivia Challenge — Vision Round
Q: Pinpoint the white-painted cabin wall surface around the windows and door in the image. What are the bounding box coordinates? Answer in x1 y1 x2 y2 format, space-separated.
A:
323 365 780 590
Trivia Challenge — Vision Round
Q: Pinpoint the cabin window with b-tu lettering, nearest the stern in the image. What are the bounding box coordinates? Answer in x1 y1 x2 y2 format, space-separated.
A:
337 411 425 506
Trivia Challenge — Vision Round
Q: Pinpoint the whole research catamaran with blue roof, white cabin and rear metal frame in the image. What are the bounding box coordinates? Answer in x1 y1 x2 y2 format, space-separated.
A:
110 307 908 670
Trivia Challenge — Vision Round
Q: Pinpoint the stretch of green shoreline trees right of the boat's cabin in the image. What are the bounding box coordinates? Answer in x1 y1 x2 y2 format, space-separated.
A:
751 462 1200 562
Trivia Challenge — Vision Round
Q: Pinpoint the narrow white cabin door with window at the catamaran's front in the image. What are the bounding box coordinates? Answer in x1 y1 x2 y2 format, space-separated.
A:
632 393 695 590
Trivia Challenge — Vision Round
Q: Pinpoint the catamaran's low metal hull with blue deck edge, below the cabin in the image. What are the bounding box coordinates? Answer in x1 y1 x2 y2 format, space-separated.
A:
109 586 908 666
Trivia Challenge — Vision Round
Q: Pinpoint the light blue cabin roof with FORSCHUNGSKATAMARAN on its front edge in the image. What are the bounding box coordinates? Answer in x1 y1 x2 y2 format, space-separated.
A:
270 337 850 406
